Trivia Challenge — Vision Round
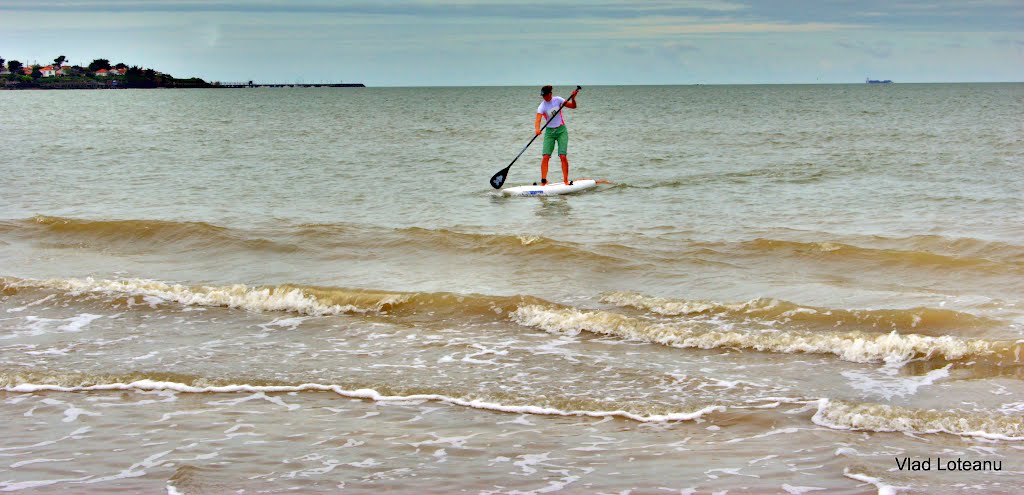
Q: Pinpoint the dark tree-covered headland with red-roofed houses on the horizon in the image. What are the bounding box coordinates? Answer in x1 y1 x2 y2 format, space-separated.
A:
0 55 213 89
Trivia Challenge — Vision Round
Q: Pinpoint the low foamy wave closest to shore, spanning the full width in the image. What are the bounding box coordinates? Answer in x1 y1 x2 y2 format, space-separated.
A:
0 370 1024 441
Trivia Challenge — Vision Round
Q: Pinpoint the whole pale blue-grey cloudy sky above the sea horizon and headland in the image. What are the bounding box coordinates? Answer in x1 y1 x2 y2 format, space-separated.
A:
0 0 1024 86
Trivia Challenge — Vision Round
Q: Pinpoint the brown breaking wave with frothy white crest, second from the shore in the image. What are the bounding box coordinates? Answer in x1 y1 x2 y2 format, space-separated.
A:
0 278 1024 367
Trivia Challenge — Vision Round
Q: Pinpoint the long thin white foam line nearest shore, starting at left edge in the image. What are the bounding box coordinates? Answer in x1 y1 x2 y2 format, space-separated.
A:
0 380 726 422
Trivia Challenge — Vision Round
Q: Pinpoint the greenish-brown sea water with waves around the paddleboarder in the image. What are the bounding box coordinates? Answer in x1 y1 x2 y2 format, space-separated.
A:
0 84 1024 494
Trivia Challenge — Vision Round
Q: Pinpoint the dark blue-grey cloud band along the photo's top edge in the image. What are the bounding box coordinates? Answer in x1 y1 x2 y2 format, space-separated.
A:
0 0 1024 33
